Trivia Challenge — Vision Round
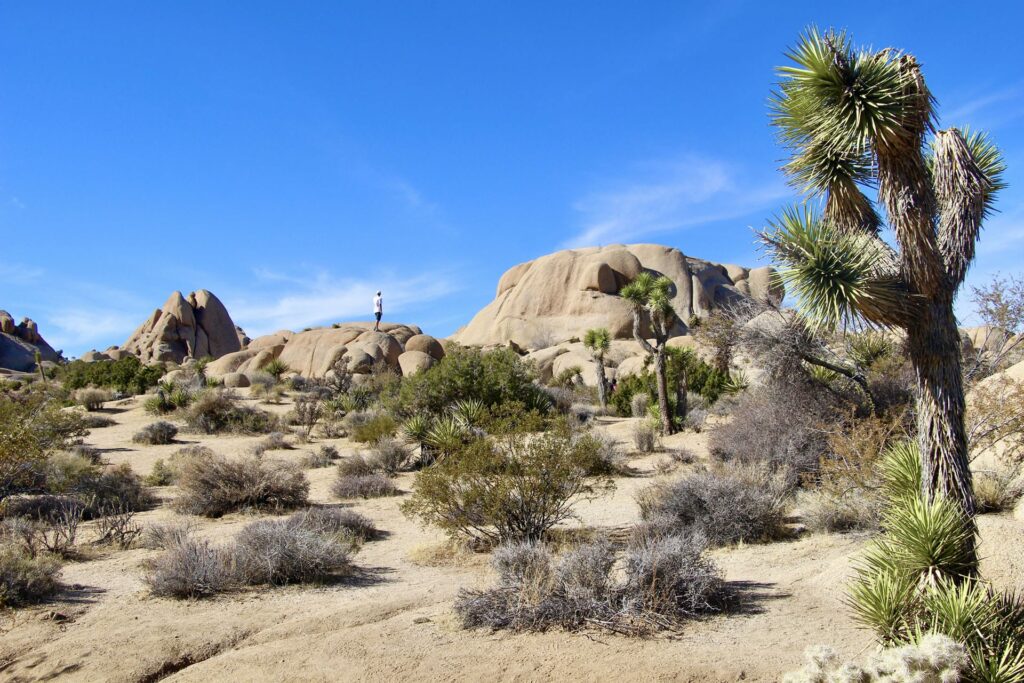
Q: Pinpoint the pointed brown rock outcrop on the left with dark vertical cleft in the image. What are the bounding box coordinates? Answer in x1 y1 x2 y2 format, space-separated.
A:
121 290 245 362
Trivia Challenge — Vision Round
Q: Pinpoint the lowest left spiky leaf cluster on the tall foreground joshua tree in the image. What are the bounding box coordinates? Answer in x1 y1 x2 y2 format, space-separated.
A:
761 205 913 330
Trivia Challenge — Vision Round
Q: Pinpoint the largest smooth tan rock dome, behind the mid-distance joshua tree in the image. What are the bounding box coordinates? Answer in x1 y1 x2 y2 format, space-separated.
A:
453 245 783 349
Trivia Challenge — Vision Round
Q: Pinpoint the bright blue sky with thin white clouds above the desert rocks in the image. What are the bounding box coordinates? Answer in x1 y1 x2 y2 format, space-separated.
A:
0 0 1024 354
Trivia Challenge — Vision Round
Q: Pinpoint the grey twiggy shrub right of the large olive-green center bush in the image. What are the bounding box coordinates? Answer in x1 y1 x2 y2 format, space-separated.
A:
637 466 792 546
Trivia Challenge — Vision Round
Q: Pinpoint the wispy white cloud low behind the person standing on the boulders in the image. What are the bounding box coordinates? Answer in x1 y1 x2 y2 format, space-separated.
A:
232 270 458 337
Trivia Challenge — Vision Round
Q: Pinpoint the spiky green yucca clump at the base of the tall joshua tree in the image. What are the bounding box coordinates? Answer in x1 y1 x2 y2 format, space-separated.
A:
849 442 1024 683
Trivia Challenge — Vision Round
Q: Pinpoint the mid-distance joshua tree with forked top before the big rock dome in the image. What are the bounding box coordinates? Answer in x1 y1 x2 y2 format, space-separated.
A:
620 272 686 434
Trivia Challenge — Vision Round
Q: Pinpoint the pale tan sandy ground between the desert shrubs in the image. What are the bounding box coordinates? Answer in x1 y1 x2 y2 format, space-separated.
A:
0 393 1024 681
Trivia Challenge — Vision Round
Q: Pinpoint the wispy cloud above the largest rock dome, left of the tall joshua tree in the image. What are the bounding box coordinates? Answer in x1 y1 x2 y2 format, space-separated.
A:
564 156 791 247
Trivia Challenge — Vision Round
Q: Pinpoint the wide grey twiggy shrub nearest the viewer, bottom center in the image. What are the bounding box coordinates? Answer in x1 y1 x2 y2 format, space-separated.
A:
456 537 724 634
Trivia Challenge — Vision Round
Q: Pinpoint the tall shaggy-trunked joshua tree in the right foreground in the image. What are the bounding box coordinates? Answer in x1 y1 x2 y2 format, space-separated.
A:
762 29 1005 565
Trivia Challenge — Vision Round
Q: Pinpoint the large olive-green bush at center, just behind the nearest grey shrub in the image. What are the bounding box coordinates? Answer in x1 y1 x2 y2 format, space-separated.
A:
402 431 612 543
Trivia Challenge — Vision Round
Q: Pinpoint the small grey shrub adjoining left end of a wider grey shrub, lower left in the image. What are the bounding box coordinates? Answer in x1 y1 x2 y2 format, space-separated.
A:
145 533 233 598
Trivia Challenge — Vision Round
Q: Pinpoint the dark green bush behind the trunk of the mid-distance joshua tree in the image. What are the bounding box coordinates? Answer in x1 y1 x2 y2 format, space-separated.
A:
611 346 741 417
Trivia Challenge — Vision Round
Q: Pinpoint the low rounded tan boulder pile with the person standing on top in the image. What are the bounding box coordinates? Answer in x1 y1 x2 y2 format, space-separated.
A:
206 323 444 382
